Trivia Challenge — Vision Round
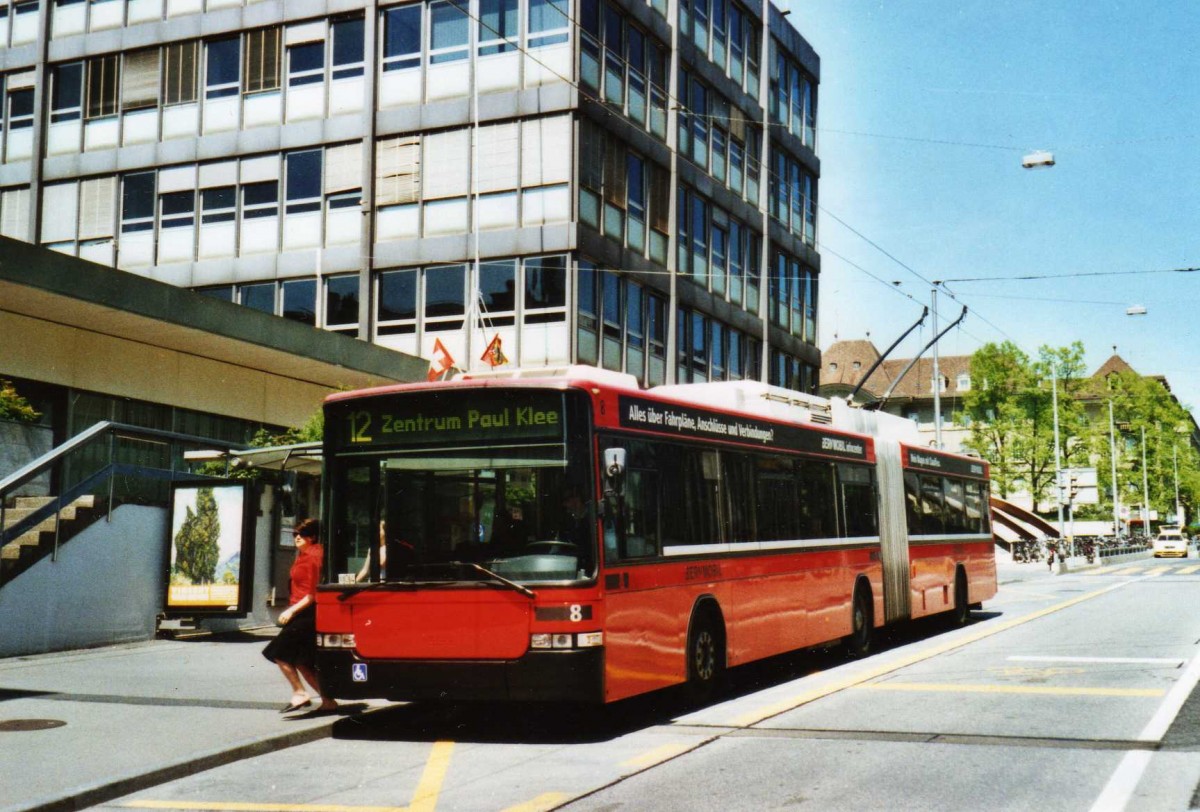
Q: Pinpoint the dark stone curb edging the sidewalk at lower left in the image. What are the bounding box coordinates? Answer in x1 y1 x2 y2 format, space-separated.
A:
13 720 340 812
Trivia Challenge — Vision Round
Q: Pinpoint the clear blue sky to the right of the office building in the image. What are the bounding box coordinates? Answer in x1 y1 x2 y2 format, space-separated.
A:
784 0 1200 415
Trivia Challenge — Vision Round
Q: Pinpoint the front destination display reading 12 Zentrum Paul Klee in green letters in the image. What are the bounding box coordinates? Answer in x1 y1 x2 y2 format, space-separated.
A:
326 390 565 447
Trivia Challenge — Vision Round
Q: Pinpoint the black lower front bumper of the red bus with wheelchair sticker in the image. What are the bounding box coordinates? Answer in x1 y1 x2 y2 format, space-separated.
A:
317 648 604 703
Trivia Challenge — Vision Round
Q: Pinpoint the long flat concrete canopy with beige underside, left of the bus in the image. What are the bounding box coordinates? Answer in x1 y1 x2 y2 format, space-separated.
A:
0 237 428 426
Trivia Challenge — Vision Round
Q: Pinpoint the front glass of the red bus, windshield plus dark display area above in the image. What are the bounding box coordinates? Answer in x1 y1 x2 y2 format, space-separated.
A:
325 391 598 587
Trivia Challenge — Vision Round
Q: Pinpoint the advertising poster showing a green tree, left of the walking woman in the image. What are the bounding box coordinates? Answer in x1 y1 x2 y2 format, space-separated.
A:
167 481 253 614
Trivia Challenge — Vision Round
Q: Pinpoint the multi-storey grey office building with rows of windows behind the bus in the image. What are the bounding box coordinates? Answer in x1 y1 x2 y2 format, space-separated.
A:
0 0 820 391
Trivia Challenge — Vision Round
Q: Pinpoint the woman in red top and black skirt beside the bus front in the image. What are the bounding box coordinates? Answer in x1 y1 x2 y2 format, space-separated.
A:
263 519 337 714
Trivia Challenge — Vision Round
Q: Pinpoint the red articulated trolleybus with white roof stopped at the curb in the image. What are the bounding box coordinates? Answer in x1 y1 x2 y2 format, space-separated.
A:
317 367 996 703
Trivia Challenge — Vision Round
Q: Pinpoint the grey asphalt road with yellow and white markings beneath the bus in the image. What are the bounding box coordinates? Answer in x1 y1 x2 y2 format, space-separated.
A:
96 560 1200 812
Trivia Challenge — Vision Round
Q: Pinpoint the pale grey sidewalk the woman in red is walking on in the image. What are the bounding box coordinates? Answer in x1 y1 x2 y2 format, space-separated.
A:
0 630 379 812
